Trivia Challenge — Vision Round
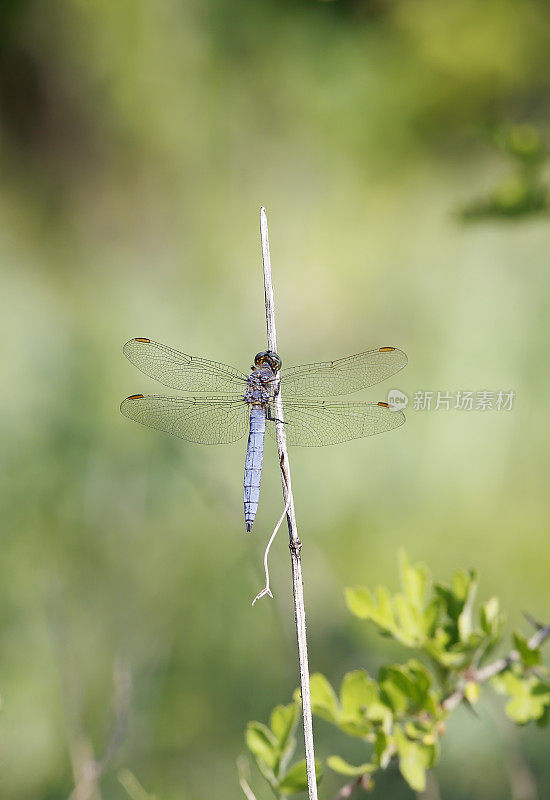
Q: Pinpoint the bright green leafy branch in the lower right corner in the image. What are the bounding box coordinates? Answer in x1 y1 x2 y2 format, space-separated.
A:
246 552 550 800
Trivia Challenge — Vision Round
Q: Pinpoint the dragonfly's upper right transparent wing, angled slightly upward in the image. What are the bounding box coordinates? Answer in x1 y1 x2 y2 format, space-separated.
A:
281 347 407 400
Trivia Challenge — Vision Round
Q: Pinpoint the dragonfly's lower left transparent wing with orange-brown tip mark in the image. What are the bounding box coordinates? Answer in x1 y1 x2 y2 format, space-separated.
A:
120 394 250 444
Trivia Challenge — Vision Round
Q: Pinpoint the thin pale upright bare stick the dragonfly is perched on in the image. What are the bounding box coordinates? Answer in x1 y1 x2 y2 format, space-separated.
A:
260 208 317 800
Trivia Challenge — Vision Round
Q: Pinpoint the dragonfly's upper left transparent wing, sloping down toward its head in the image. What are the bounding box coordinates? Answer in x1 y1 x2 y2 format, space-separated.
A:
122 339 246 394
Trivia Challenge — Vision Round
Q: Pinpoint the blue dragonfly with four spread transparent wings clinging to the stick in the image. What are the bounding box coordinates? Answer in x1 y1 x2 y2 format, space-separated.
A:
120 338 407 532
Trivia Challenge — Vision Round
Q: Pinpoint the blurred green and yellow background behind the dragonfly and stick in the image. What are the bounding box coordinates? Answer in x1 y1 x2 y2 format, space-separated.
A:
0 0 550 800
